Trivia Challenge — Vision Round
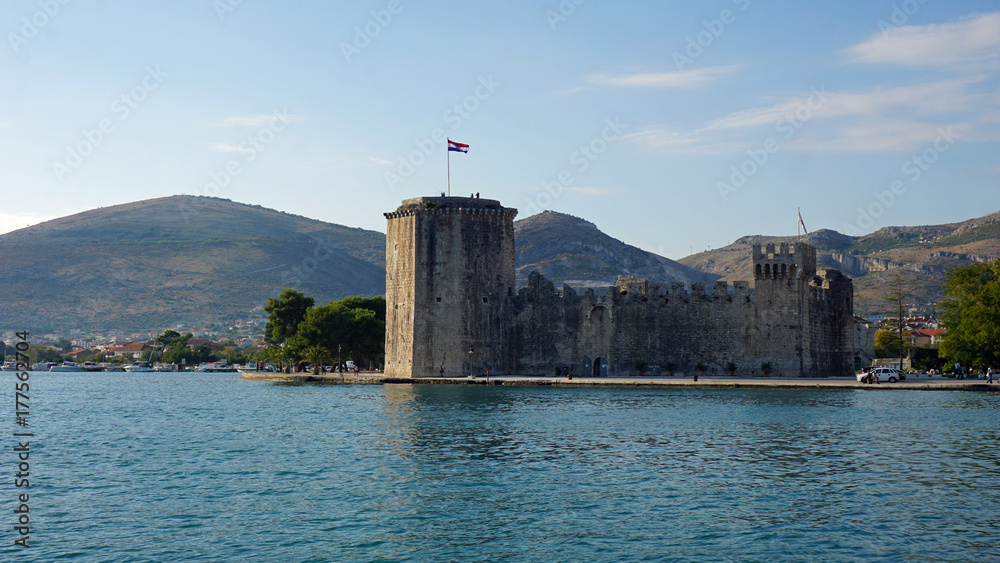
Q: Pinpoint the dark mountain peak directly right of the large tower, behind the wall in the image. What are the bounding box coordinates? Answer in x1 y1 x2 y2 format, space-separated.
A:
514 211 718 288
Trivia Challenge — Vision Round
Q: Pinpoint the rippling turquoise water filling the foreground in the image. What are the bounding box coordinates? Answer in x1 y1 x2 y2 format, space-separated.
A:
0 372 1000 561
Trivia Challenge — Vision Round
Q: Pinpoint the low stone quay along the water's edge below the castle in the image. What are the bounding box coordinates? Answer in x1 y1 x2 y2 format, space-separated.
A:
241 372 1000 392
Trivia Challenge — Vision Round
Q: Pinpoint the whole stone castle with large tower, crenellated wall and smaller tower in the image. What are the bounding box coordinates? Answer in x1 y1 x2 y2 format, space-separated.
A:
385 196 854 377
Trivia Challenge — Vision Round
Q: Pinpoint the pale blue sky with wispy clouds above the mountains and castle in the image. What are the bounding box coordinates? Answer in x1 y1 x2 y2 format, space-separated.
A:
0 0 1000 259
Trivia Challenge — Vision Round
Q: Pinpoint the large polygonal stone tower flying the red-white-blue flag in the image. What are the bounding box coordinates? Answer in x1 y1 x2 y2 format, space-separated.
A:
385 197 517 377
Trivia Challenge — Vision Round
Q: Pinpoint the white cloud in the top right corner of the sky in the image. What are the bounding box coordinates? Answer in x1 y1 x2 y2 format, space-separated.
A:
844 12 1000 66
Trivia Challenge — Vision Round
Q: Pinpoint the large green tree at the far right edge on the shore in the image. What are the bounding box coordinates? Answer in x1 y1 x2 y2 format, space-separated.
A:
941 260 1000 368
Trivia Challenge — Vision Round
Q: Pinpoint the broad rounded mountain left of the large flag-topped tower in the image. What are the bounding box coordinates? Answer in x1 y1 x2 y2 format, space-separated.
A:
0 196 385 331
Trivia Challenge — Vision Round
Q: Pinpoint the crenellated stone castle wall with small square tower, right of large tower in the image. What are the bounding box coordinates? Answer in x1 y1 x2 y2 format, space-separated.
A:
514 240 853 377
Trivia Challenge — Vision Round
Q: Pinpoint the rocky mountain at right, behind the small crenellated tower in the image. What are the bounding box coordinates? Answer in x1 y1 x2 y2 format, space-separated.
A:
679 213 1000 315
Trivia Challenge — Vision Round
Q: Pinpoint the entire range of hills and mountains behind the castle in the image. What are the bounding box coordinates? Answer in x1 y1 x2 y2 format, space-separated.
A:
0 196 1000 333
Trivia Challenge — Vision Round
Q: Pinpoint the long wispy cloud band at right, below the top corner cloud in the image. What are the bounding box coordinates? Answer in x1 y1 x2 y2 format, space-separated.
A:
626 75 1000 156
